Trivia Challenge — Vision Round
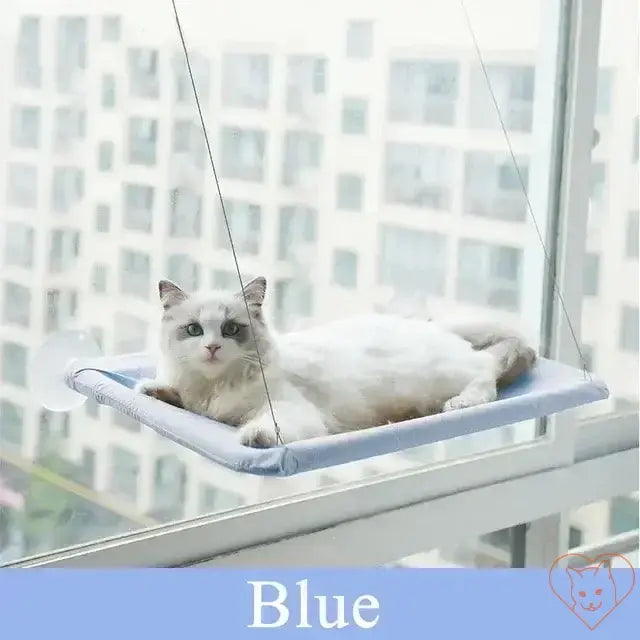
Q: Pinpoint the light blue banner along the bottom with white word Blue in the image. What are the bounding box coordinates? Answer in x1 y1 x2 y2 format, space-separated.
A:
0 569 640 640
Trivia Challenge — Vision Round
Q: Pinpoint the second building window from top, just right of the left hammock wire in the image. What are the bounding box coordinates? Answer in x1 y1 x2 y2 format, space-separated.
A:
222 127 266 182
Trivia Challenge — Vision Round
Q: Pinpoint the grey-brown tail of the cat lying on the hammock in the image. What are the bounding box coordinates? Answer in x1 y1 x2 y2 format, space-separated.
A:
447 321 537 388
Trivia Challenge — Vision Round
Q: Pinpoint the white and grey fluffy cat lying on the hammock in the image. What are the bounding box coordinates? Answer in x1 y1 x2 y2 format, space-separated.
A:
137 277 536 447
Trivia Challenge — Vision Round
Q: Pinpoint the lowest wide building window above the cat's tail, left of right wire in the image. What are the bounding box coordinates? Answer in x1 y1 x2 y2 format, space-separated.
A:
457 238 522 311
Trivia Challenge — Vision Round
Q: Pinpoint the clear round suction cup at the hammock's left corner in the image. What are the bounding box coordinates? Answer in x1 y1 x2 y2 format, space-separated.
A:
31 329 101 411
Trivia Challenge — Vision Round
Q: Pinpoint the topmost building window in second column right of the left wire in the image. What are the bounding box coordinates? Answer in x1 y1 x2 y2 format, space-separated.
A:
286 56 327 114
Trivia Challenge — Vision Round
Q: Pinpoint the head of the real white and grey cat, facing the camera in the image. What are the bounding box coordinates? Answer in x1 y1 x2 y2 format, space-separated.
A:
158 277 270 379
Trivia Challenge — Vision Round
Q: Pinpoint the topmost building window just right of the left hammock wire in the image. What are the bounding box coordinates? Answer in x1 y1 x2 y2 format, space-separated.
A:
222 53 270 109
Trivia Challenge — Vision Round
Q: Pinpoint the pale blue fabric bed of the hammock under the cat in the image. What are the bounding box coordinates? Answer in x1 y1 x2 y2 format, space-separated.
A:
66 354 609 476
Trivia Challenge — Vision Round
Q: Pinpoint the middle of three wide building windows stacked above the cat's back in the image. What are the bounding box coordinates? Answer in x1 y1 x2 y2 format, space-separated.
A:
385 143 453 209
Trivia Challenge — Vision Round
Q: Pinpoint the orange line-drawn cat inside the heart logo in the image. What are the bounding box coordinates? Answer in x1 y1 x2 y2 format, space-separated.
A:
567 560 618 627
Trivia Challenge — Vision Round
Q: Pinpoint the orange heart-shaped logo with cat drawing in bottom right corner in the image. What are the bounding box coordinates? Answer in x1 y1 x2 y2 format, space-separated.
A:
549 553 636 631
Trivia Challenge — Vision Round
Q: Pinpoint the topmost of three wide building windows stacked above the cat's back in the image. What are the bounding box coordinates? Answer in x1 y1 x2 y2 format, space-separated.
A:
389 60 459 126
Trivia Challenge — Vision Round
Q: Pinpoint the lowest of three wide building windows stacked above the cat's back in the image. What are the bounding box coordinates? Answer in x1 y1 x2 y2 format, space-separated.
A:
378 224 447 295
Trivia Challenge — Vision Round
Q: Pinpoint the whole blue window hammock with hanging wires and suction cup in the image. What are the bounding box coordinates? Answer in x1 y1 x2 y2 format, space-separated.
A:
34 0 609 476
